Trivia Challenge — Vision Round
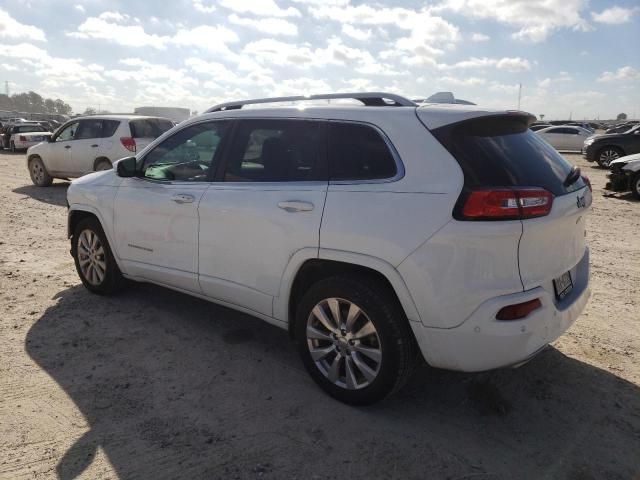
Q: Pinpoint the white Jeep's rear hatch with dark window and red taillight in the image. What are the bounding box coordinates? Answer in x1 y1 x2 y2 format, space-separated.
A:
428 110 591 299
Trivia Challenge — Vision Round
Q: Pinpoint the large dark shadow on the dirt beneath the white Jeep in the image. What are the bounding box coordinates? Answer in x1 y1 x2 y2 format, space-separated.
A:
26 284 640 480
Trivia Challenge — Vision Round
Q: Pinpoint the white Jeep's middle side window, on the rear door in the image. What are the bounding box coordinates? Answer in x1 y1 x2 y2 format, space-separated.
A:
224 120 327 182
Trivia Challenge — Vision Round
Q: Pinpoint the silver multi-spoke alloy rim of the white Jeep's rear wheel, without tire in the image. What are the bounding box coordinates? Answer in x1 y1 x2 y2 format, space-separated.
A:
306 298 382 390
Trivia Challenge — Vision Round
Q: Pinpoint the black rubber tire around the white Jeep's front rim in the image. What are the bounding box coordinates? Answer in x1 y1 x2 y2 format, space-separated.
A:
71 217 125 295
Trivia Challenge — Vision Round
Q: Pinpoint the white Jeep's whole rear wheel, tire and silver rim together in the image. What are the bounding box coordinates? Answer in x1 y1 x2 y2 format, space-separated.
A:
295 275 416 405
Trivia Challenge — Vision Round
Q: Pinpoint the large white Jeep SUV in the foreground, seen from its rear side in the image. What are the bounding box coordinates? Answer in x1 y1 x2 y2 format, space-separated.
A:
67 93 592 404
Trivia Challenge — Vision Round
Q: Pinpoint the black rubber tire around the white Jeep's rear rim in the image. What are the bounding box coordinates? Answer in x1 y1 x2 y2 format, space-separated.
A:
295 275 418 405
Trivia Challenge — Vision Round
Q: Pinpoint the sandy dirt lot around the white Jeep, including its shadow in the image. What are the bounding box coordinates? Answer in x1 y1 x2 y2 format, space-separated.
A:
0 153 640 480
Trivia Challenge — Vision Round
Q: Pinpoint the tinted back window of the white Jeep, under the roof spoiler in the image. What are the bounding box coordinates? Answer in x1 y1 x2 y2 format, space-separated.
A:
432 116 585 195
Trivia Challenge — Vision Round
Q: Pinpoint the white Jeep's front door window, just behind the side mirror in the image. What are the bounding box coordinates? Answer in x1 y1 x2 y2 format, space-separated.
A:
142 121 227 182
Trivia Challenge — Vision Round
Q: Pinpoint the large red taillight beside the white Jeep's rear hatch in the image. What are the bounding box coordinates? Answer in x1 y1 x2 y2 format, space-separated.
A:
462 188 553 220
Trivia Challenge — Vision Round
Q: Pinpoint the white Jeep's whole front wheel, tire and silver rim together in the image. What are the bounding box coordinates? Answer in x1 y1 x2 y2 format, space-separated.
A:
71 217 124 295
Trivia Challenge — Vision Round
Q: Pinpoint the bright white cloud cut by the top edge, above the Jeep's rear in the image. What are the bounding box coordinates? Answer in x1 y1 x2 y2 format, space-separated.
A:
432 0 589 42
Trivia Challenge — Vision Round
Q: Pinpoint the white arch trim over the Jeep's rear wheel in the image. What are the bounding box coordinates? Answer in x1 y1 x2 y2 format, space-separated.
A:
274 249 420 336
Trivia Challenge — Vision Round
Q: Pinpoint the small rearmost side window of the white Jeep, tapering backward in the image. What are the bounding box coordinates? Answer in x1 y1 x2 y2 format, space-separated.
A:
329 122 398 180
